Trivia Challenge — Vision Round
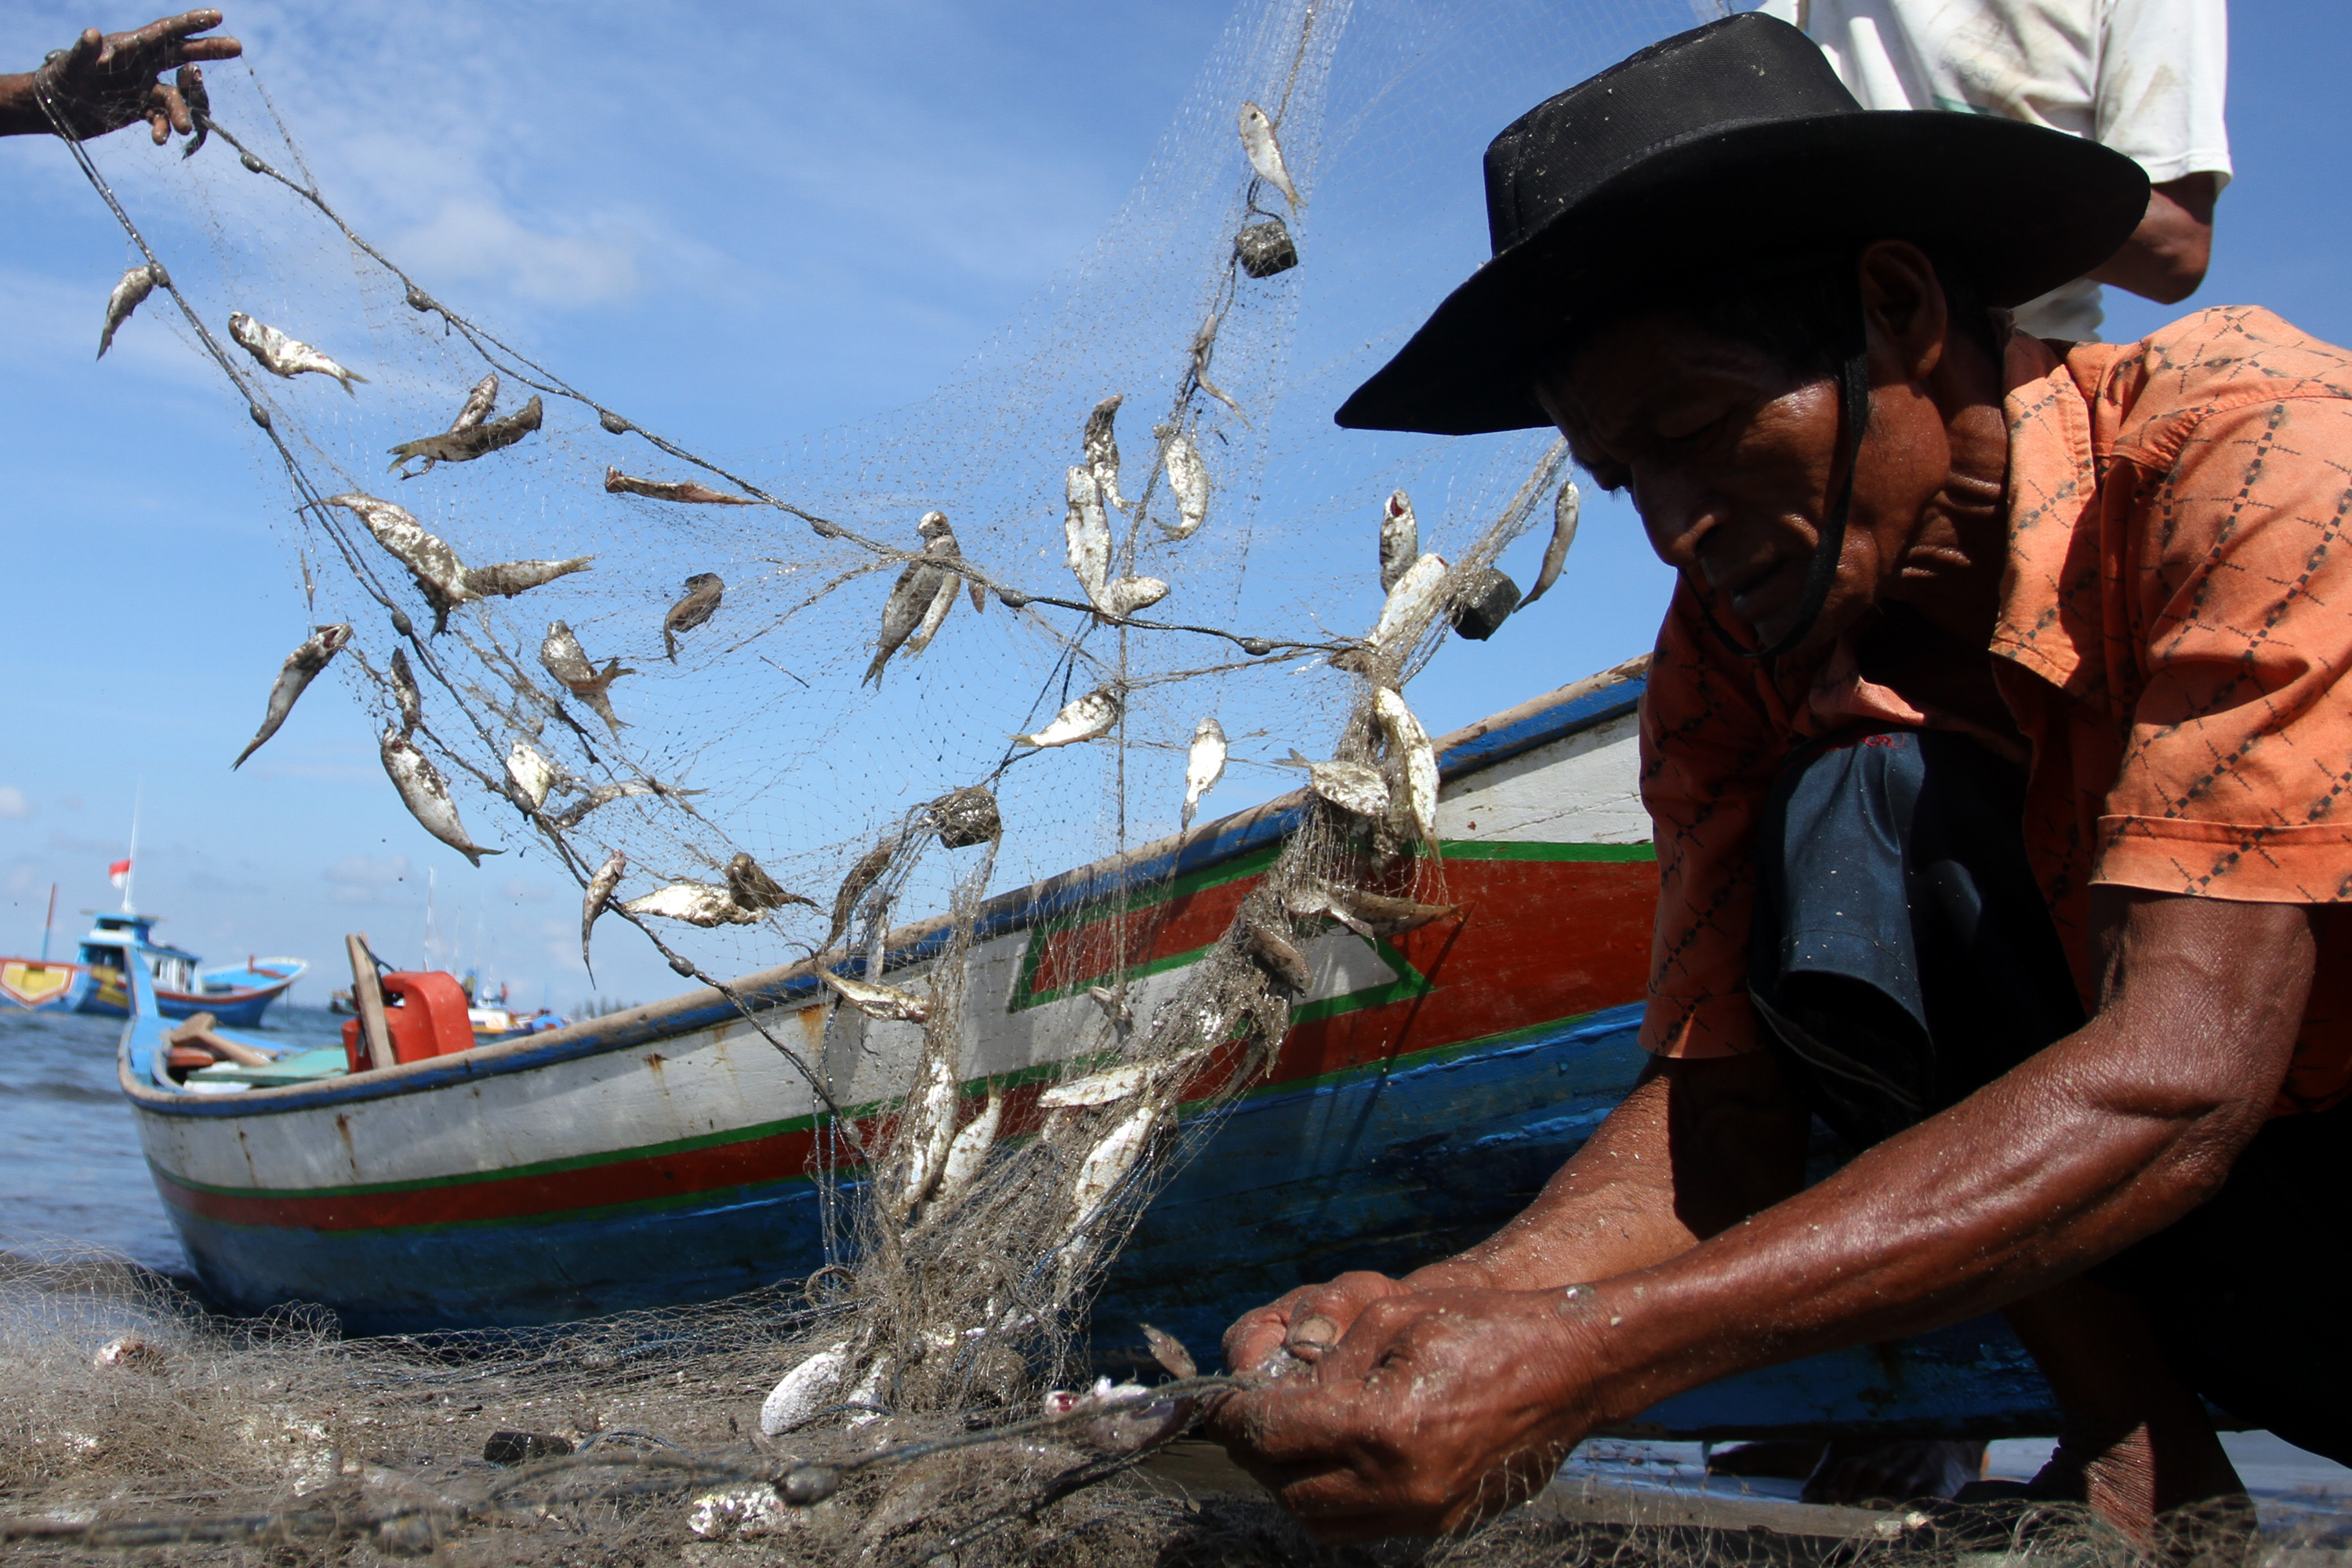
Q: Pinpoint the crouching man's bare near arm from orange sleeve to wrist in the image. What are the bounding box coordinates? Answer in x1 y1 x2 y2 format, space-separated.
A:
1562 900 2314 1420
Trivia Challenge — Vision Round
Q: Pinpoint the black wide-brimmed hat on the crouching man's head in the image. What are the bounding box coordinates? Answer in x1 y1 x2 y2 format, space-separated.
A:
1338 12 2147 435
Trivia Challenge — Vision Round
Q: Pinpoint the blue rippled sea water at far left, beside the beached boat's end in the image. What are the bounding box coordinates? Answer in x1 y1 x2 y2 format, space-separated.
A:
0 1001 343 1279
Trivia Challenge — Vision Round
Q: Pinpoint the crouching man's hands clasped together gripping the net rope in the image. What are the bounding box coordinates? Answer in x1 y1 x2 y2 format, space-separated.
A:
1209 1274 1595 1540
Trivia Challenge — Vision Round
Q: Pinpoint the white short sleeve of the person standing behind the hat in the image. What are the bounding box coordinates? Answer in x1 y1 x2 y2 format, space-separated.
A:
2093 0 2230 188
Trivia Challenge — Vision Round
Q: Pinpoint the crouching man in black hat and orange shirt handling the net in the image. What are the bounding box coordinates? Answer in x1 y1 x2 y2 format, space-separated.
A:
1214 14 2352 1540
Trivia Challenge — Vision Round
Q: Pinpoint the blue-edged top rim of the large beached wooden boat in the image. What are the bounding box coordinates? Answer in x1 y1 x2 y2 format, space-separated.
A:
115 654 1649 1116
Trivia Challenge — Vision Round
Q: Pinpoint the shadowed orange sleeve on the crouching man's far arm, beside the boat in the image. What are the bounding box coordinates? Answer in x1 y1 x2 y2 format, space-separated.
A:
1642 583 1788 1058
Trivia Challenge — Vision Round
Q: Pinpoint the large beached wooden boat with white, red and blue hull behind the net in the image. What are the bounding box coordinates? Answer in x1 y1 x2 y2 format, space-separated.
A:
120 661 2056 1436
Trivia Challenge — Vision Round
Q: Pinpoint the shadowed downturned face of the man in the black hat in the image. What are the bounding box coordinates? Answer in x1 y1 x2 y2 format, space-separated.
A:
1536 315 1943 649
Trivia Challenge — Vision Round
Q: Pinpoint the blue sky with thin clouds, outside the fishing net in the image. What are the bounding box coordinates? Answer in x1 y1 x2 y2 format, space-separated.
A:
0 0 2352 1004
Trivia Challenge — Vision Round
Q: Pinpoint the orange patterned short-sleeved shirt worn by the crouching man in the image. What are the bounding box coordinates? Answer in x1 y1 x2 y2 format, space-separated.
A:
1642 308 2352 1112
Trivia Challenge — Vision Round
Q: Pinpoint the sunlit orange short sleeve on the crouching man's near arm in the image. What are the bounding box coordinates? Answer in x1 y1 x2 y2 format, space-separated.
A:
2091 395 2352 902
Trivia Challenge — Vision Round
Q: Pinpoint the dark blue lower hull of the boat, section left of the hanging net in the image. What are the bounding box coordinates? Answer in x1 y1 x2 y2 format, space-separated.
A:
169 1180 826 1333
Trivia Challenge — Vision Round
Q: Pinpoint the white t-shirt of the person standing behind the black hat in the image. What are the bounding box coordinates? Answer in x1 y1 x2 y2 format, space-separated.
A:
1757 0 2230 343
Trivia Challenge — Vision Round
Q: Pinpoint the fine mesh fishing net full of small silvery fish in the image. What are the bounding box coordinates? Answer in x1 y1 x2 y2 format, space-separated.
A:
0 0 2201 1563
